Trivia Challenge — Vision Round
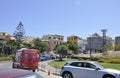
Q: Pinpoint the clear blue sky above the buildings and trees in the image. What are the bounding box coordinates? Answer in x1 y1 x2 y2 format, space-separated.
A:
0 0 120 39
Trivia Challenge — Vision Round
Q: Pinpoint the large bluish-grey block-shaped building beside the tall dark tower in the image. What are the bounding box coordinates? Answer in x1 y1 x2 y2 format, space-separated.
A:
87 33 112 51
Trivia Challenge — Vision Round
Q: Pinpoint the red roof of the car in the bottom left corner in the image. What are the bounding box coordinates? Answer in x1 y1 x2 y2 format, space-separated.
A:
0 69 33 78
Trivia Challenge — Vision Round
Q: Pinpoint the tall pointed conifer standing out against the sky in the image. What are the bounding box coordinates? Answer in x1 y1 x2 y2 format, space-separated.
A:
13 22 25 48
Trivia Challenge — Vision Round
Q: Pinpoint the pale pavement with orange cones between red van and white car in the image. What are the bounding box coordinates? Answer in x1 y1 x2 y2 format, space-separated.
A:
37 60 62 78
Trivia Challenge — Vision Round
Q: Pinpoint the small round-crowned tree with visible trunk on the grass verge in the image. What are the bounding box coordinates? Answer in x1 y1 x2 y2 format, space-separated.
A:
57 45 68 61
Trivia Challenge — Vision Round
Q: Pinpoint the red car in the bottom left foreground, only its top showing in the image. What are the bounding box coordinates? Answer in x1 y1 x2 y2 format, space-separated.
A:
0 69 43 78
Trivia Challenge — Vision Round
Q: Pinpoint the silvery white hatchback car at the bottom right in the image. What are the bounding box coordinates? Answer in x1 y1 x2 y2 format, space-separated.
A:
60 61 120 78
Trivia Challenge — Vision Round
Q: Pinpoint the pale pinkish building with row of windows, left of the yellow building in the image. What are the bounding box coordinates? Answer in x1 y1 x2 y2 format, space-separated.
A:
41 34 64 51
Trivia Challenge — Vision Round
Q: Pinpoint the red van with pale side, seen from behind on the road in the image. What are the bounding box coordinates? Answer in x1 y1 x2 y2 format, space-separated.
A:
12 48 39 72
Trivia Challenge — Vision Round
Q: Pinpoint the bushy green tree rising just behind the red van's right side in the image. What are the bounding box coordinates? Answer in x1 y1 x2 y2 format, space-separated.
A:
33 38 48 54
